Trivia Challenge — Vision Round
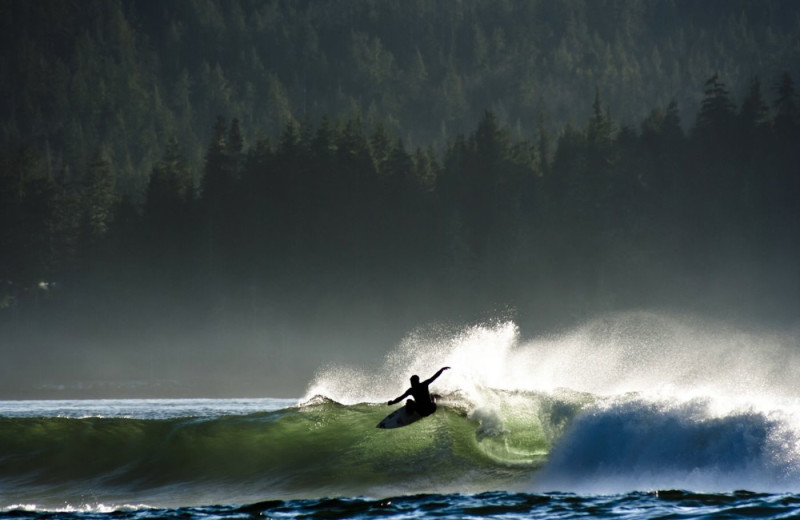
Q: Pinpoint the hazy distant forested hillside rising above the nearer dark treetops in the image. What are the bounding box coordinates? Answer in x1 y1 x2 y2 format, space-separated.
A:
0 0 800 193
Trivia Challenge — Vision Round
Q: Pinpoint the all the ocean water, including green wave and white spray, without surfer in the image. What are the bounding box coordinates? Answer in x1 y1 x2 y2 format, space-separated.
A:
0 314 800 519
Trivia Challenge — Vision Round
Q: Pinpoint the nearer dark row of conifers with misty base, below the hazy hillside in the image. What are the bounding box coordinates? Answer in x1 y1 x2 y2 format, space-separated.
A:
0 73 800 330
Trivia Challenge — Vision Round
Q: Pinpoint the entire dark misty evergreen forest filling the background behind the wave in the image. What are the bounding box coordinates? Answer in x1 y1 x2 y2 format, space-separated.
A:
0 0 800 398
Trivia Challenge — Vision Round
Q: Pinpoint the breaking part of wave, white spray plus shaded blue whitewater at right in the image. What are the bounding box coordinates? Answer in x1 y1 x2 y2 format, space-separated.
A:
308 312 800 492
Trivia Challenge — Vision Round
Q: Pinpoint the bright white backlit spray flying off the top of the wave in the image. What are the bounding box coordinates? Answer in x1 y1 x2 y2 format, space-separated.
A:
306 312 800 404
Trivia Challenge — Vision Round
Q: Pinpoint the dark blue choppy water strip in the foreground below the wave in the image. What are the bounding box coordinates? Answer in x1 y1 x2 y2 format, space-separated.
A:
9 491 800 520
